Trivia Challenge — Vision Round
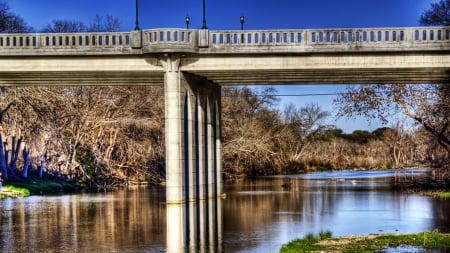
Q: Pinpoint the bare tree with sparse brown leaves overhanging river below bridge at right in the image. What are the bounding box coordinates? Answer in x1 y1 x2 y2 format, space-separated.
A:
335 84 450 155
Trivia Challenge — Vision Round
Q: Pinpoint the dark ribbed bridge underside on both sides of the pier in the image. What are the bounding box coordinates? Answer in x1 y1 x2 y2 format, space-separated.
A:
0 67 450 86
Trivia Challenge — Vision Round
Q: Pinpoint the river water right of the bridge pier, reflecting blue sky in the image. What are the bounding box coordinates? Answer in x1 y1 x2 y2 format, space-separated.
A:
224 177 450 252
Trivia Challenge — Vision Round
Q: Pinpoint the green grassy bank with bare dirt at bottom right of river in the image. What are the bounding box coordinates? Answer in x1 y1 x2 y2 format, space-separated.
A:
280 231 450 253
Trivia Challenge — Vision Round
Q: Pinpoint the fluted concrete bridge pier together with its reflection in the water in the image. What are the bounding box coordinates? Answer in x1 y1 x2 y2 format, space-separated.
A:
161 57 223 252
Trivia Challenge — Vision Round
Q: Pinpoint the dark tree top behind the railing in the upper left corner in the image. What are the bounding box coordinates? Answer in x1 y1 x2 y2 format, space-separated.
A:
0 2 33 33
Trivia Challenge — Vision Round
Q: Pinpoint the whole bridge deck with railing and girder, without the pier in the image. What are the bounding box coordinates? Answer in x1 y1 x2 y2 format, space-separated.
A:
0 27 450 85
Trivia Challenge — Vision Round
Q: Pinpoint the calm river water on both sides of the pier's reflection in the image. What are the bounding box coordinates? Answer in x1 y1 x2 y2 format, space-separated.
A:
0 171 450 252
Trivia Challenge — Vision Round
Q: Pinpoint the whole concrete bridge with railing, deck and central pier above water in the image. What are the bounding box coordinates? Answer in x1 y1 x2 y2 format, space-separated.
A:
0 27 450 208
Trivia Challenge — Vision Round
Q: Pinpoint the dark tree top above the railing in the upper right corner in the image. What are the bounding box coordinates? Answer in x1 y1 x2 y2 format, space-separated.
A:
419 0 450 26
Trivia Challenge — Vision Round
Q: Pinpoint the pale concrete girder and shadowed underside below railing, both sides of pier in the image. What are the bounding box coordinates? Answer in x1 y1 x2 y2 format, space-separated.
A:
0 53 450 86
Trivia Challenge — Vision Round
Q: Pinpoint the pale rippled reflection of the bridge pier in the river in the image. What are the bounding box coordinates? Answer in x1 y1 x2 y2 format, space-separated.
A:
167 199 223 253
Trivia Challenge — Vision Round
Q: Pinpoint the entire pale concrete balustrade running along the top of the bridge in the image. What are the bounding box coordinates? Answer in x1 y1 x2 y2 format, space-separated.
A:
0 26 450 56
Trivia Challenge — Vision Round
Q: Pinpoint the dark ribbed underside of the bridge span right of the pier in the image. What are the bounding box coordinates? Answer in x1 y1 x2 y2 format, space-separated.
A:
186 68 450 85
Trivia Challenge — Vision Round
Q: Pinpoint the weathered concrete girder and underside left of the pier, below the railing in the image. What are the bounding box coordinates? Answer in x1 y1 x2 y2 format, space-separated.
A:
0 56 164 86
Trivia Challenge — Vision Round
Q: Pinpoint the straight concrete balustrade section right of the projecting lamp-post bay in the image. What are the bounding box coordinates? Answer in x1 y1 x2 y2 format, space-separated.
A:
209 27 450 52
